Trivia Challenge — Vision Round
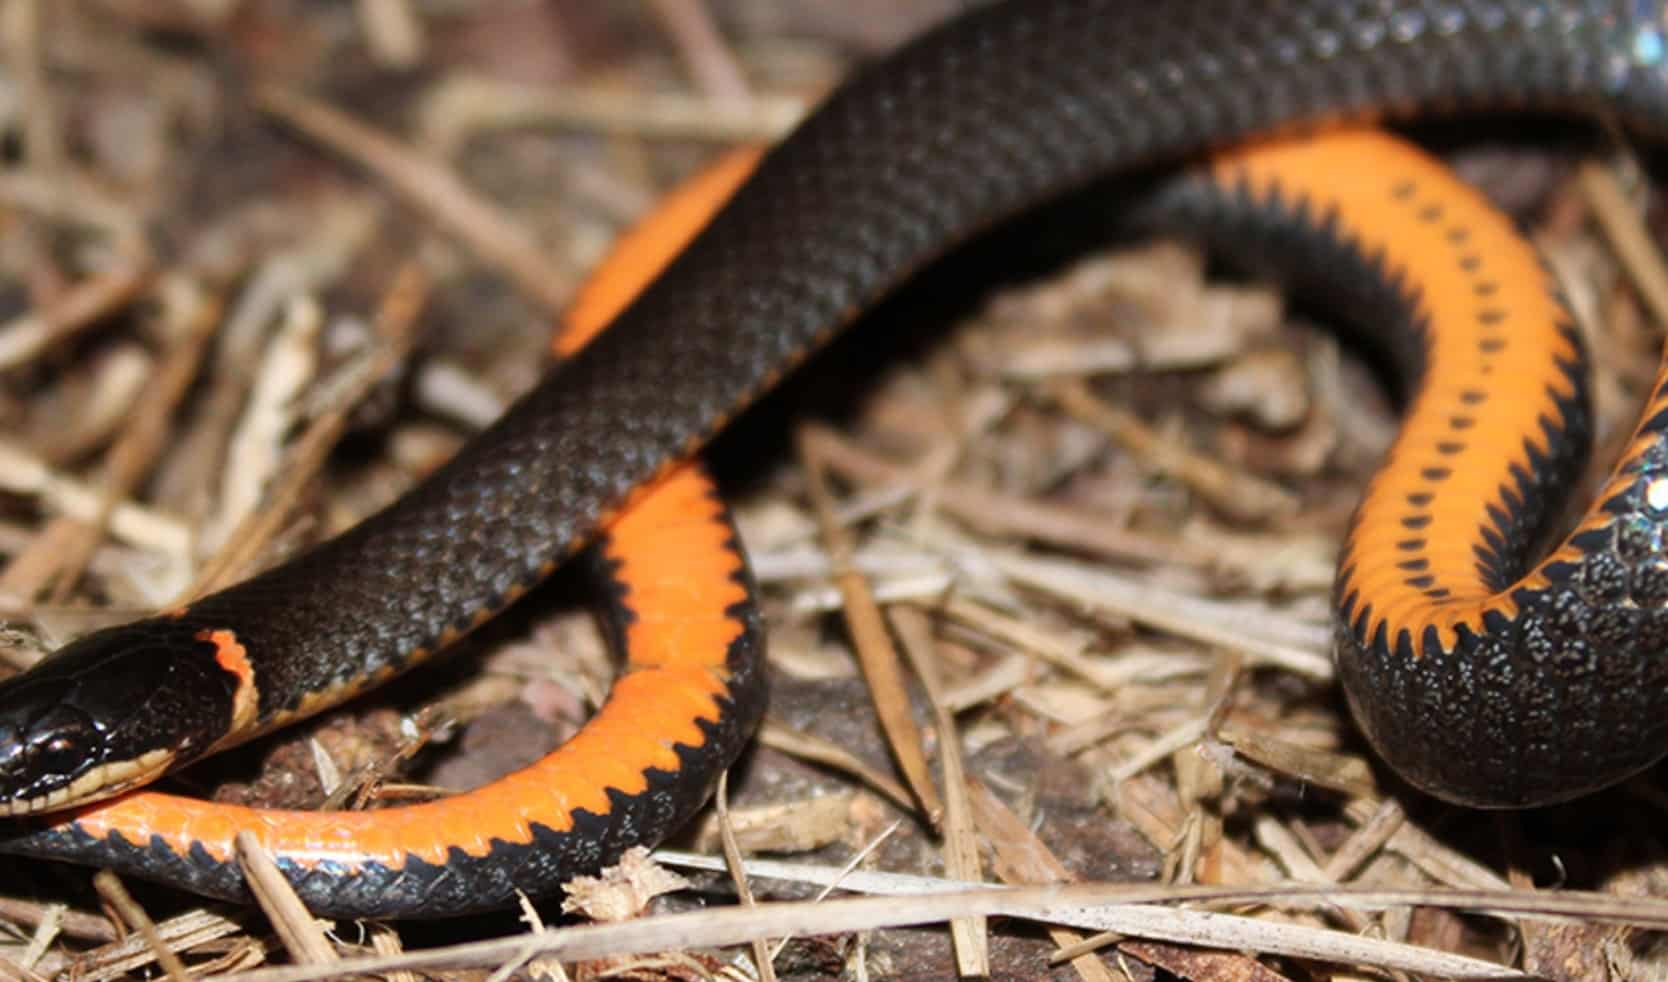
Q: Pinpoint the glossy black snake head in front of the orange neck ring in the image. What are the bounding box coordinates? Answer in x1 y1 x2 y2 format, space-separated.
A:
0 617 239 815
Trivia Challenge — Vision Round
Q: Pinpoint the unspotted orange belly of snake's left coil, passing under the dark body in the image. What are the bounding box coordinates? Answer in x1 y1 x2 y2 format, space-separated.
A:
58 153 757 867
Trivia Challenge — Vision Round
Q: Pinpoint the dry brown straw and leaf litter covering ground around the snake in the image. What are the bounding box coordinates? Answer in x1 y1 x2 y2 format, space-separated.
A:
0 0 1668 980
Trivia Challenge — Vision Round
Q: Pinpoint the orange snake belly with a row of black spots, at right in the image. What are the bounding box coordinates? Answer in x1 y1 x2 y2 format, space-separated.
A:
1216 130 1576 649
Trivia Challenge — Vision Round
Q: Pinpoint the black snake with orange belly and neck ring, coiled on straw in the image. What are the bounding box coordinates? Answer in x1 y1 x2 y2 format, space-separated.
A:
0 0 1668 917
